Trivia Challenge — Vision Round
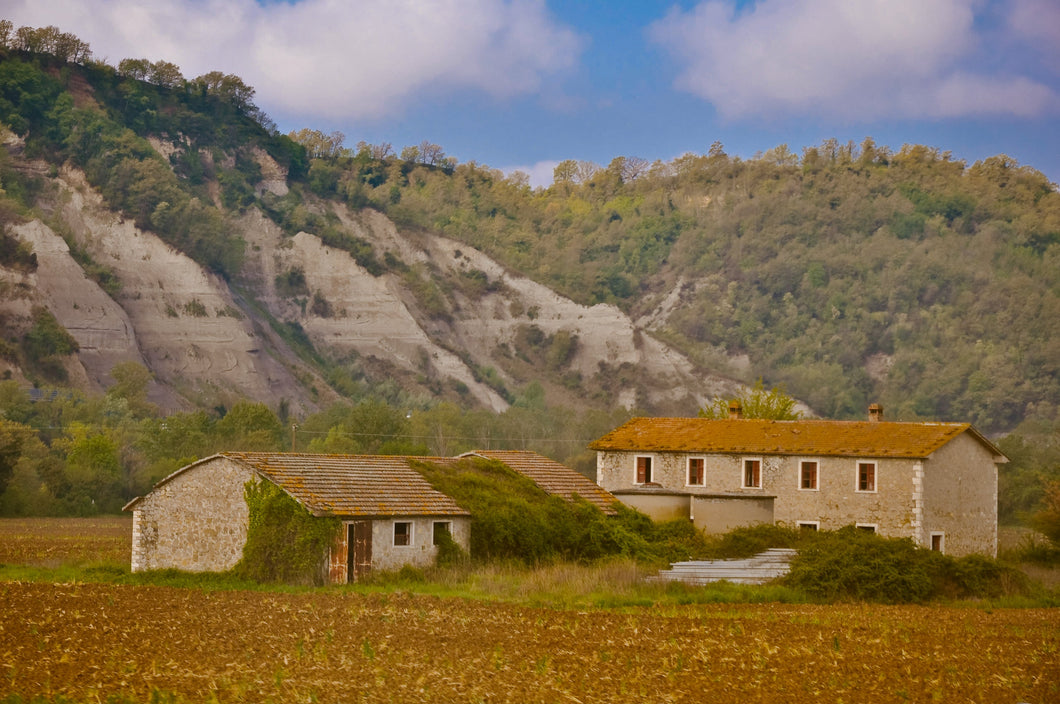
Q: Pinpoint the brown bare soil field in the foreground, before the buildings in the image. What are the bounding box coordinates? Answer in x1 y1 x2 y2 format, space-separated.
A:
0 522 1060 704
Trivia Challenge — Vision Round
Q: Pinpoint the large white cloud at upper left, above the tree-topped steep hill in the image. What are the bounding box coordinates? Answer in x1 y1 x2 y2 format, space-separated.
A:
3 0 582 119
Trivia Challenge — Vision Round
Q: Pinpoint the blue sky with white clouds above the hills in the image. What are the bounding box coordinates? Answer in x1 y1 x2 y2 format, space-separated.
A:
0 0 1060 186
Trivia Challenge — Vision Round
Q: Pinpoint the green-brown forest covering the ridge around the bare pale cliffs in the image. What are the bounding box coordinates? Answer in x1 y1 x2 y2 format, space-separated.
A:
0 26 1060 515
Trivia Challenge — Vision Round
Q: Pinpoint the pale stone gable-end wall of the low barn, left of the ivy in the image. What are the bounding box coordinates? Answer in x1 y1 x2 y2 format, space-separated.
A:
125 457 257 571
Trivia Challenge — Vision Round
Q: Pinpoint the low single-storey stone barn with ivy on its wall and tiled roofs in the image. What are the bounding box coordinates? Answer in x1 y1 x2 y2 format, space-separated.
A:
125 451 616 584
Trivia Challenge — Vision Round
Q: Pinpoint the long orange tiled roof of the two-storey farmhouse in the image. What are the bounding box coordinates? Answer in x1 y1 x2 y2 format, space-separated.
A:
589 418 1002 458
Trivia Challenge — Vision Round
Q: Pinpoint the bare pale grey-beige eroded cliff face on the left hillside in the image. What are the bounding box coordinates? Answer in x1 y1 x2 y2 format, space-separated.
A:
0 153 738 415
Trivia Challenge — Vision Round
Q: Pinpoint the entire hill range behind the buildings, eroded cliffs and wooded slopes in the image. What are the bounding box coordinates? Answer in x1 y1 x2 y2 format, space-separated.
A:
0 39 1060 441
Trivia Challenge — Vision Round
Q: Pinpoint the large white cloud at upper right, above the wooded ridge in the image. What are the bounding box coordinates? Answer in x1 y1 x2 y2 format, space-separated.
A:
649 0 1058 119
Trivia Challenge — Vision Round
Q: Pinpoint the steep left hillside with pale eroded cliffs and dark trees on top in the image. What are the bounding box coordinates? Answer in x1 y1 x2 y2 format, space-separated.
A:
0 48 738 428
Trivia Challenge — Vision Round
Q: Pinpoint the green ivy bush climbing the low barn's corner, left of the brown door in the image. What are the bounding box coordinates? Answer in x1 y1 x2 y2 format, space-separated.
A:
232 481 341 585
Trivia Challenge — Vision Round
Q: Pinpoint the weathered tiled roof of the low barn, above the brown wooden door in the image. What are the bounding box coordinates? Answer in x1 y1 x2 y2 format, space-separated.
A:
222 453 470 516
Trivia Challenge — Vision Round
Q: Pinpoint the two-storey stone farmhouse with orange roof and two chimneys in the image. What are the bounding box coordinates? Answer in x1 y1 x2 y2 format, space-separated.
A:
589 404 1008 556
